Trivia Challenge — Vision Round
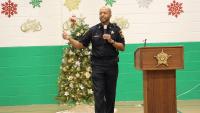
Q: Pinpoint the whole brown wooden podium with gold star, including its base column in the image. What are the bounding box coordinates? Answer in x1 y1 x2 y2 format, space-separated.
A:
135 46 184 113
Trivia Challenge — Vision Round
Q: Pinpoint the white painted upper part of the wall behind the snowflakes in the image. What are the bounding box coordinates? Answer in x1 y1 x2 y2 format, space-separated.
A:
0 0 200 47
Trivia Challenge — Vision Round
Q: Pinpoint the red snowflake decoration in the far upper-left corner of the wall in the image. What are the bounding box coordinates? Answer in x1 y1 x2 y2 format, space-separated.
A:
1 0 17 18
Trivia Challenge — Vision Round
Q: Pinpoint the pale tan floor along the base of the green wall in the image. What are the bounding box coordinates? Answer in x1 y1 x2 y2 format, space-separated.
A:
0 100 200 113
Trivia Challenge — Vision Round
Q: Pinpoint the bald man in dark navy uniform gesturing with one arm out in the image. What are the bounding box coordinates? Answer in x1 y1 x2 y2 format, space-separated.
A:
63 6 125 113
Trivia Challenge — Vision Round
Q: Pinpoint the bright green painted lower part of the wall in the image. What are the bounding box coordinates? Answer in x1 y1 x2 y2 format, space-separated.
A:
0 42 200 106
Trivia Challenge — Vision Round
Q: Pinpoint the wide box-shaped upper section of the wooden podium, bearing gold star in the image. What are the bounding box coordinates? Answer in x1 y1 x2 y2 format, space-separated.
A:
134 46 184 70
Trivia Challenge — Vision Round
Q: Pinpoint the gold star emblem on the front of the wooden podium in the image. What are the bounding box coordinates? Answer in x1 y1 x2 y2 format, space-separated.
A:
154 49 172 66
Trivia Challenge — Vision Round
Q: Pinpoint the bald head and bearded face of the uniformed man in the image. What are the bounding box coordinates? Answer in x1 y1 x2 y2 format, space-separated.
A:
99 7 111 23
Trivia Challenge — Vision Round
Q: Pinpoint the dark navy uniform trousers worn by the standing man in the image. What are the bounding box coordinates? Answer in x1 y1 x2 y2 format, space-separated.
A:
92 64 118 113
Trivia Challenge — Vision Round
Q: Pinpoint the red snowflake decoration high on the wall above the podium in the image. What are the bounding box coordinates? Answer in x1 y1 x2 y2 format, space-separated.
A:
167 0 184 18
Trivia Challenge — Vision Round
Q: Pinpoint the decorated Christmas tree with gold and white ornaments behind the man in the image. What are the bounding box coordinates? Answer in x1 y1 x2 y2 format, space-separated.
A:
57 16 93 105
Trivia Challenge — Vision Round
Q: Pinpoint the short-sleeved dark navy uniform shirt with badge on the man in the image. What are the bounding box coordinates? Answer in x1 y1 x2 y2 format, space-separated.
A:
80 23 125 65
